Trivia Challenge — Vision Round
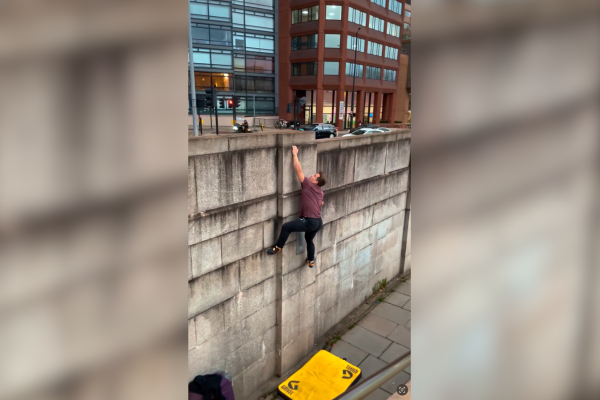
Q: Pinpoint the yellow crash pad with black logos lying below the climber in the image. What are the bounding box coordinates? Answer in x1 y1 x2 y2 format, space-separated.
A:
278 350 361 400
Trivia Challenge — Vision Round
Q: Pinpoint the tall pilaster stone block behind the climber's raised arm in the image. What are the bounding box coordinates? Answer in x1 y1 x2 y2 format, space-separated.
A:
282 145 317 194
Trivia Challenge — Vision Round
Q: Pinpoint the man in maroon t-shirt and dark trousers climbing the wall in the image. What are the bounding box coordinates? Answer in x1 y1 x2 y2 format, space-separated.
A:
267 146 325 268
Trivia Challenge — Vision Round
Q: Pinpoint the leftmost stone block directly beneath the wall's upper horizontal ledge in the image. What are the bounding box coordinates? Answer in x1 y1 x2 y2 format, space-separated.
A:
188 208 238 245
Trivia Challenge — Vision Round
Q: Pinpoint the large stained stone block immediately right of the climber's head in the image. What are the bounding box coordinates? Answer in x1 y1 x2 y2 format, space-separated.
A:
317 149 356 190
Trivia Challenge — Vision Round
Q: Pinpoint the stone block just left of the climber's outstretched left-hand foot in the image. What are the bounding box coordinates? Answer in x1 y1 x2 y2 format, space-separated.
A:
221 223 264 264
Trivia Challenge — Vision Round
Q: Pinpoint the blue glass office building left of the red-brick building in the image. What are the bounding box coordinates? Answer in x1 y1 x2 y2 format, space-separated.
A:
190 0 278 117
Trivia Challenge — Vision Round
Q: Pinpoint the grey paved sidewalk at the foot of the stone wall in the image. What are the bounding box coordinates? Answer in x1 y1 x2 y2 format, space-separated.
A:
331 279 411 400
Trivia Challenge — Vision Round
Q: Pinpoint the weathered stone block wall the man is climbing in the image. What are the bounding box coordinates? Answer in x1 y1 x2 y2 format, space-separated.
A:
188 132 410 399
